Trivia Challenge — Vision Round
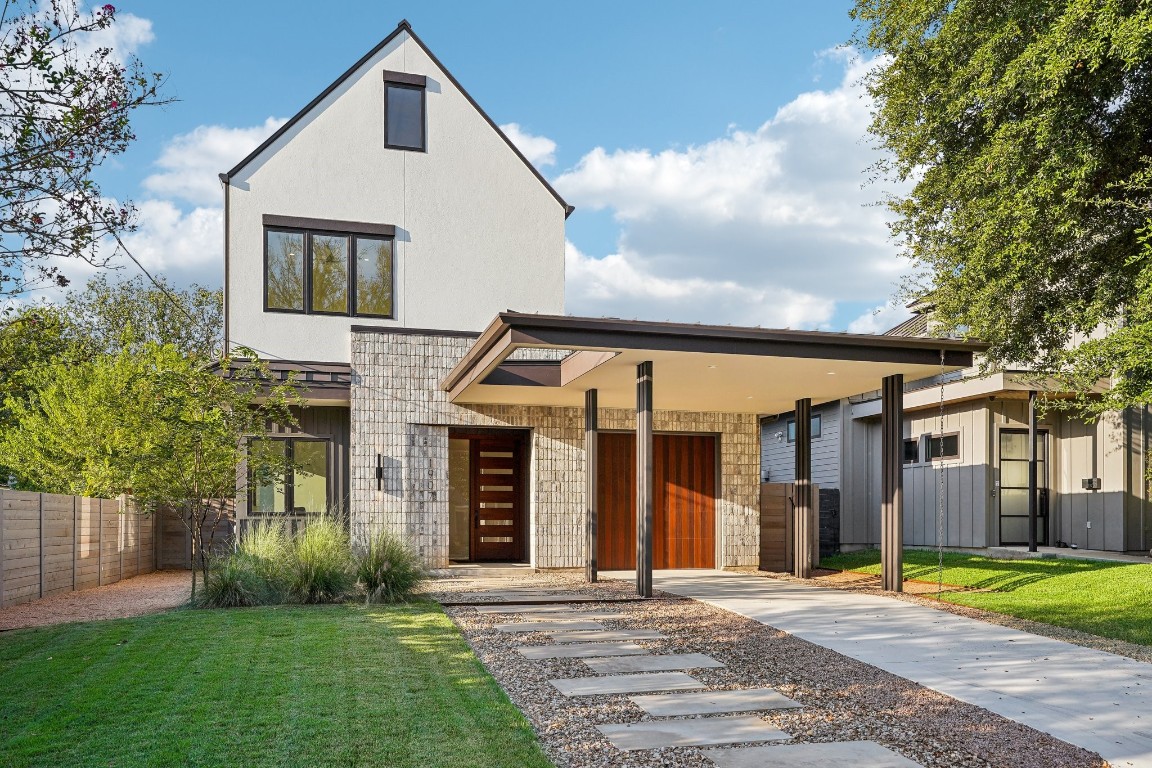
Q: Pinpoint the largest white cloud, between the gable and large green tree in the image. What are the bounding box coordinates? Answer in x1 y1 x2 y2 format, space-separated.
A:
555 50 907 318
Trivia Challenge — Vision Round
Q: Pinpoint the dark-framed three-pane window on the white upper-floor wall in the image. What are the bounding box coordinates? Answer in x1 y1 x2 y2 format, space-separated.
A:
264 215 396 319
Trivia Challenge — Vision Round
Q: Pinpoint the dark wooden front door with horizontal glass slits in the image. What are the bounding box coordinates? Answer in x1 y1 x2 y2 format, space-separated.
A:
470 438 525 561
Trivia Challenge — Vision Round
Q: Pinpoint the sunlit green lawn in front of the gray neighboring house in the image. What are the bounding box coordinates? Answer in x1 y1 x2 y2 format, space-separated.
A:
820 549 1152 645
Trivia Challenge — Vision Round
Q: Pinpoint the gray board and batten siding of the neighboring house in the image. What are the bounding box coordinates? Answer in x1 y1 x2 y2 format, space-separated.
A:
834 397 1152 552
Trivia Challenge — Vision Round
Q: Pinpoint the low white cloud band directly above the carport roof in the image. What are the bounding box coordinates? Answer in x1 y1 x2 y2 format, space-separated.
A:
564 243 833 328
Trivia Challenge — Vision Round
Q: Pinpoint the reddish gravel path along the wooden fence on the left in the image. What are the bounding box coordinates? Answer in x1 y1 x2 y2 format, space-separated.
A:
0 571 192 632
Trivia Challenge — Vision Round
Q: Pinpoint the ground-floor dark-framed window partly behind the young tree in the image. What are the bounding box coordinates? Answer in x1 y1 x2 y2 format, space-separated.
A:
248 435 332 516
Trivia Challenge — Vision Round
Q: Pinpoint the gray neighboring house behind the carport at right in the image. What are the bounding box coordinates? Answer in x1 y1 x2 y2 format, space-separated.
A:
760 306 1152 552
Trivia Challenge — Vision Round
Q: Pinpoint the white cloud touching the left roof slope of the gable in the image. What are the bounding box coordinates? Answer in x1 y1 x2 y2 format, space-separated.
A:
144 117 286 205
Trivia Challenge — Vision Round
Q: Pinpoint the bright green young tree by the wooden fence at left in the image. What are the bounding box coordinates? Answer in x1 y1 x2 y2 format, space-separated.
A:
0 343 302 596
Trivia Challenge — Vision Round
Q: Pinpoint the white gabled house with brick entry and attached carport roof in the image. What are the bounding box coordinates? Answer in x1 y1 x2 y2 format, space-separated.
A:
221 22 976 569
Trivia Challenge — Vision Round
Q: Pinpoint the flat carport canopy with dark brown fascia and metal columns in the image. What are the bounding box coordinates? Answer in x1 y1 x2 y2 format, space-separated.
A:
441 312 986 594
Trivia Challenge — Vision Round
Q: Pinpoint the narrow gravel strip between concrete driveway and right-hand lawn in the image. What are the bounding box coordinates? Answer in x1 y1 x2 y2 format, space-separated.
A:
729 568 1152 662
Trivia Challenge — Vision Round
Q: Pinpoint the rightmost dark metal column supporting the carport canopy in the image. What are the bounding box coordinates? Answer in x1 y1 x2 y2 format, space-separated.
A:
880 373 904 592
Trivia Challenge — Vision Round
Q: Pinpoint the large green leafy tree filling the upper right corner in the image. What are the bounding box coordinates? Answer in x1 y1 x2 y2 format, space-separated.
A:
852 0 1152 409
